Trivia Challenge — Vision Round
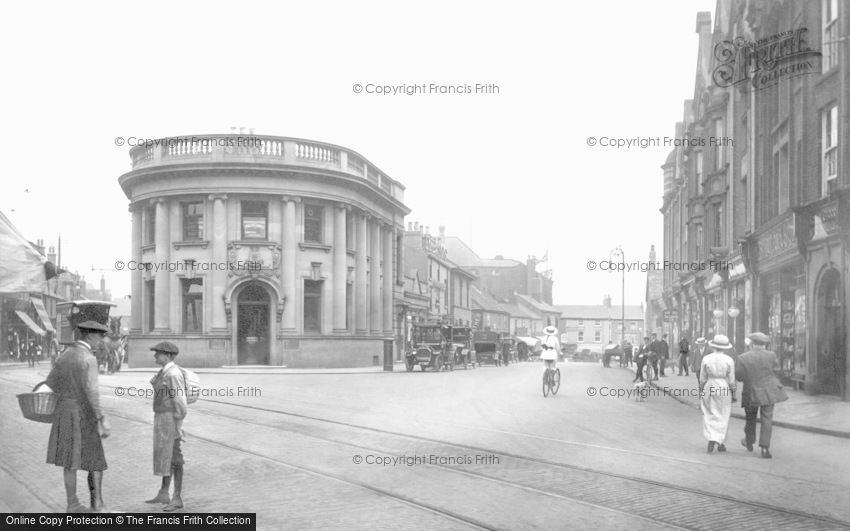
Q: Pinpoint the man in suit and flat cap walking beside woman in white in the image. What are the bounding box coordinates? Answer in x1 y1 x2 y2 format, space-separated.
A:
735 332 788 459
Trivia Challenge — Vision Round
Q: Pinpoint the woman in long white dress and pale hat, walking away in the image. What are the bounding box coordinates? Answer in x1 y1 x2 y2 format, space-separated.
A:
699 334 736 453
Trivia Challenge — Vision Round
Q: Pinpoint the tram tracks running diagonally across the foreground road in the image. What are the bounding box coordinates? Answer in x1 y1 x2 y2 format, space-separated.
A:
3 374 850 529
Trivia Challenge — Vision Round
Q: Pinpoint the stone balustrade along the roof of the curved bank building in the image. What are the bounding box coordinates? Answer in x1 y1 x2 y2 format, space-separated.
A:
130 134 403 200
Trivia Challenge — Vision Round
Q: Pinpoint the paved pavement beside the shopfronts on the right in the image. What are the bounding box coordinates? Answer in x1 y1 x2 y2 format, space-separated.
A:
612 364 850 438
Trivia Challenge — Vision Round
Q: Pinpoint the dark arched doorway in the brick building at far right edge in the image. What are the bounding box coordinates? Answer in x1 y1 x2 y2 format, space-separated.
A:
815 269 847 396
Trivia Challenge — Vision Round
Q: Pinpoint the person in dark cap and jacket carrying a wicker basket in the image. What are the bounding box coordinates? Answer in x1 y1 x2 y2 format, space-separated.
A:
47 321 110 513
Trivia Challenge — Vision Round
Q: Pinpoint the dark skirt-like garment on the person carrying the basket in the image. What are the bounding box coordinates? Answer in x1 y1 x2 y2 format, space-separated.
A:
47 399 106 472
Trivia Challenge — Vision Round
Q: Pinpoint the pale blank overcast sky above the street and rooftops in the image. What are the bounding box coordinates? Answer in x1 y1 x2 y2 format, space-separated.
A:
0 0 715 304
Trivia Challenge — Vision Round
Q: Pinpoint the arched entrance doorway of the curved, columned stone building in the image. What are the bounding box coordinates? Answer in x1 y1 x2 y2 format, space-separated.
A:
236 284 272 365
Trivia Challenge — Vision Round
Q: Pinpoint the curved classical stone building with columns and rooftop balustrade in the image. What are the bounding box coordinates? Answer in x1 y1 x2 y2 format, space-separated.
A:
119 135 410 367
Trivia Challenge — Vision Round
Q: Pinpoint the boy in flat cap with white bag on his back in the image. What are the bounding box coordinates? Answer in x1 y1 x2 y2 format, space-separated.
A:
145 341 187 512
